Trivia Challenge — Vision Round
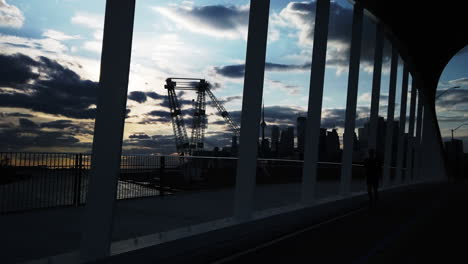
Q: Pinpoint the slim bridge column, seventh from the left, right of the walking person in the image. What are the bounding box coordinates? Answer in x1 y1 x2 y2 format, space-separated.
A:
395 63 409 183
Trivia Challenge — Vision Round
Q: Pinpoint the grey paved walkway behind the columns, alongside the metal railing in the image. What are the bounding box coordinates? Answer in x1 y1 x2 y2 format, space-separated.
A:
0 178 365 263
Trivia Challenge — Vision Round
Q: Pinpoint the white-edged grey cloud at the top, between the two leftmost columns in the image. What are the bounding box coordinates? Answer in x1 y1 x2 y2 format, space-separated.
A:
153 4 249 39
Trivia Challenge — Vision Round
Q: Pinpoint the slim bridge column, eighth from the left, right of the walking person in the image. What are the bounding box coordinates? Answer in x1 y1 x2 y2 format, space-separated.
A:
405 77 416 182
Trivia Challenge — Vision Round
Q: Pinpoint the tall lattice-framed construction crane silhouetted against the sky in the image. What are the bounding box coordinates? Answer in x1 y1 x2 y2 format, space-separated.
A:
164 78 239 156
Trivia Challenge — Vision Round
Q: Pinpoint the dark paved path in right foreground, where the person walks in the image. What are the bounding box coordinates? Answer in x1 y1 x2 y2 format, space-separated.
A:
213 180 468 263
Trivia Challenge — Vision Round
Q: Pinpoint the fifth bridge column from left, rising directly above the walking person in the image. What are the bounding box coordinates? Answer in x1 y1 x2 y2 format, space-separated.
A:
369 24 384 153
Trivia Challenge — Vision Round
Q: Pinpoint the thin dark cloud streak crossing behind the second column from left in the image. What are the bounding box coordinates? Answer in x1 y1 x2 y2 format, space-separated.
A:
214 62 310 78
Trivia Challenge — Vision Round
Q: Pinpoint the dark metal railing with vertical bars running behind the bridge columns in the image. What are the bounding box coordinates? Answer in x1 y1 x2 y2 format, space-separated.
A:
0 152 402 213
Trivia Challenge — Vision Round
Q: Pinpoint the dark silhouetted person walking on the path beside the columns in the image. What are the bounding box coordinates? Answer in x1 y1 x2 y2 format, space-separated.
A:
364 149 381 209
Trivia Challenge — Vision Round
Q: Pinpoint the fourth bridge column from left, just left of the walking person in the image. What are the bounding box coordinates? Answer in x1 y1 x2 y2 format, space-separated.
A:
340 2 363 196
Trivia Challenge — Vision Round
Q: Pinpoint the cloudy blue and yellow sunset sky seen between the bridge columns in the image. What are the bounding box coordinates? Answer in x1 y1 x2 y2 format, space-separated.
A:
0 0 468 154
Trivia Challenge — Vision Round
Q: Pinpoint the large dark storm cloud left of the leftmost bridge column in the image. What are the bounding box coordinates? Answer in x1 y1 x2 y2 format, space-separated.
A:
0 54 98 119
